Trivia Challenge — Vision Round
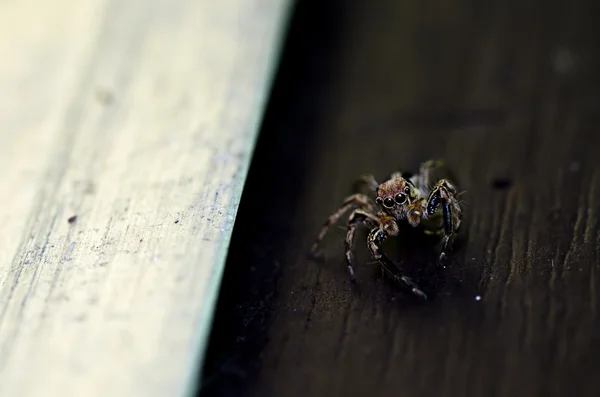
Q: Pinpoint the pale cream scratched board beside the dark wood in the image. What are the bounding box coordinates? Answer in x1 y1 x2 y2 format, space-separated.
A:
0 0 289 397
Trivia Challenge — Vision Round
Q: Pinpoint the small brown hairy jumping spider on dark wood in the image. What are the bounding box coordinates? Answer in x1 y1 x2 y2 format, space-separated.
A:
311 161 462 299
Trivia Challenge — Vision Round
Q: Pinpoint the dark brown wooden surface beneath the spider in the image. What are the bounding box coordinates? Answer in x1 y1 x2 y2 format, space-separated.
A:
203 0 600 397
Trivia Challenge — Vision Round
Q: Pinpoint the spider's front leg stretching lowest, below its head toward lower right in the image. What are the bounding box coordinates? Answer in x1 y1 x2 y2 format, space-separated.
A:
367 219 427 299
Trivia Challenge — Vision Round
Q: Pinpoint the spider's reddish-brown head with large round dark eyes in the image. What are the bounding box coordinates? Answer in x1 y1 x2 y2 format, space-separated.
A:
375 177 418 219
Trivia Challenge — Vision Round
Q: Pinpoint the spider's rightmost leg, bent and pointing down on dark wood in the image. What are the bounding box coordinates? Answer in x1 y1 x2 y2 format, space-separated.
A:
427 179 462 262
